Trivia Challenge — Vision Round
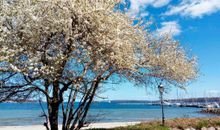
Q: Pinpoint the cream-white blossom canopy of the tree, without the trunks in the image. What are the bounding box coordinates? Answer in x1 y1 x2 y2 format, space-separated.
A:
0 0 196 83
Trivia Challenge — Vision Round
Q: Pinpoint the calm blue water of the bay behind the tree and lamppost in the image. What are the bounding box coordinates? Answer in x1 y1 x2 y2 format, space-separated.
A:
0 102 216 126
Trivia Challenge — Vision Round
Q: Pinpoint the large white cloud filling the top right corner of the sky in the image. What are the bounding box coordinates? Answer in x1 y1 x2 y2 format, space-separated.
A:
165 0 220 18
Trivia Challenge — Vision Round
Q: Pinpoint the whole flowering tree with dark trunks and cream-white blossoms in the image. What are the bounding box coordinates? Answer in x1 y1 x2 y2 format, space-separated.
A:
0 0 197 130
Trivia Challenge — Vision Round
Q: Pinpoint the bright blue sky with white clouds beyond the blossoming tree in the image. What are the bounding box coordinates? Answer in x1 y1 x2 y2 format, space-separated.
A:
102 0 220 100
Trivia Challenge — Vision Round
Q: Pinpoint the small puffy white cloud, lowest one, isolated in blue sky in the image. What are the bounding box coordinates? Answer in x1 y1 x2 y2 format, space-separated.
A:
156 21 181 36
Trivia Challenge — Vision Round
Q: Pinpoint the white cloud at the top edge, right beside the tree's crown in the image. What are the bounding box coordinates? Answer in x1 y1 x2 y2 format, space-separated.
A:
128 0 171 17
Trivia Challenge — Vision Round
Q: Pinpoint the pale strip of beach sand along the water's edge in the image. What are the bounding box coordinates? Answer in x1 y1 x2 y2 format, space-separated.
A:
0 122 140 130
